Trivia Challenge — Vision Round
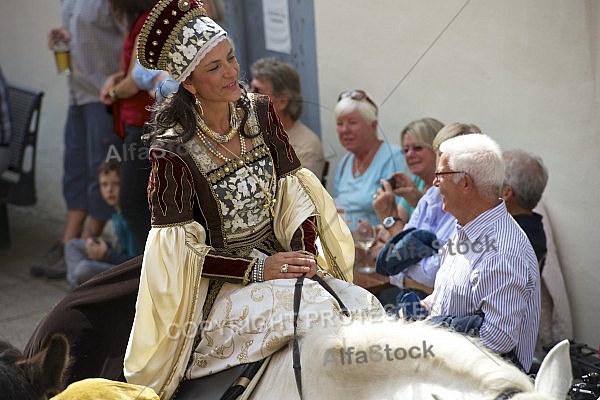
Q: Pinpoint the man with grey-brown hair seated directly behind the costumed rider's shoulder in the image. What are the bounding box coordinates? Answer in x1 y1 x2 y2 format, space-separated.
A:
250 58 325 179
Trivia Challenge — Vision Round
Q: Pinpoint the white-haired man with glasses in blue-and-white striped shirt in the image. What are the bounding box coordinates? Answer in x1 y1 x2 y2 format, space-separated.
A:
424 134 540 371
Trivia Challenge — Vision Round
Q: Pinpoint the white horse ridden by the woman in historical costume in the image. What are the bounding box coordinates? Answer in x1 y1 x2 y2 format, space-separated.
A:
243 322 572 400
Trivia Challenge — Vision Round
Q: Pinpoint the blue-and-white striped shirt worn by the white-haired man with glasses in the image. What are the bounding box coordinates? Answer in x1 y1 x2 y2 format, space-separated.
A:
427 202 540 371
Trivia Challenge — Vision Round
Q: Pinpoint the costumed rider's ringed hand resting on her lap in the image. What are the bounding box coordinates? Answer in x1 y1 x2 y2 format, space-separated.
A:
263 251 317 281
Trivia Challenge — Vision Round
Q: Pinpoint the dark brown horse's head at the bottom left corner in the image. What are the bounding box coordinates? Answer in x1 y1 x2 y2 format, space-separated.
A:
0 334 69 400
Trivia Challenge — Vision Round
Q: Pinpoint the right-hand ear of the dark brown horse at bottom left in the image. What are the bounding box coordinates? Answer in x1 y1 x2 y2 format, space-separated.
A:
17 333 70 395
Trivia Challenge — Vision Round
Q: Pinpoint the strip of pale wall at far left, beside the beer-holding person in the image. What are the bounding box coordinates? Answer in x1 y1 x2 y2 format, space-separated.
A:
0 0 68 216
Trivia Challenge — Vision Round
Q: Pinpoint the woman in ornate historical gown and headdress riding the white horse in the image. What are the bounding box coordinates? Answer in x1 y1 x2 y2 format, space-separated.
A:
125 0 382 399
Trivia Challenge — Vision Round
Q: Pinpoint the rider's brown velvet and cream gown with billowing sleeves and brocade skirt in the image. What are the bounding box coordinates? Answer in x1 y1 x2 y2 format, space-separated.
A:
124 94 384 399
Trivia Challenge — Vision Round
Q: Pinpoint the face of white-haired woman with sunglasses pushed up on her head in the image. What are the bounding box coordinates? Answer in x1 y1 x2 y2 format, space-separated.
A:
335 110 377 153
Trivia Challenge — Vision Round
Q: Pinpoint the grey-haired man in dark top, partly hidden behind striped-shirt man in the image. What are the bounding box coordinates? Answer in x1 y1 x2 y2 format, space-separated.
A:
502 150 548 267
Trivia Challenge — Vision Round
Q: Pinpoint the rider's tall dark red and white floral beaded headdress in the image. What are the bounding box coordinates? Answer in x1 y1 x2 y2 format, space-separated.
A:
138 0 227 83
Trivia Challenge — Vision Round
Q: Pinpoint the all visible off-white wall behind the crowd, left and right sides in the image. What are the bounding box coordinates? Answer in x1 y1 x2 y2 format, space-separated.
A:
0 0 600 347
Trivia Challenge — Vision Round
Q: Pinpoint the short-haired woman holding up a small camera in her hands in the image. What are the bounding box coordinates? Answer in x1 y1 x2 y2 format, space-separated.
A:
372 118 444 234
